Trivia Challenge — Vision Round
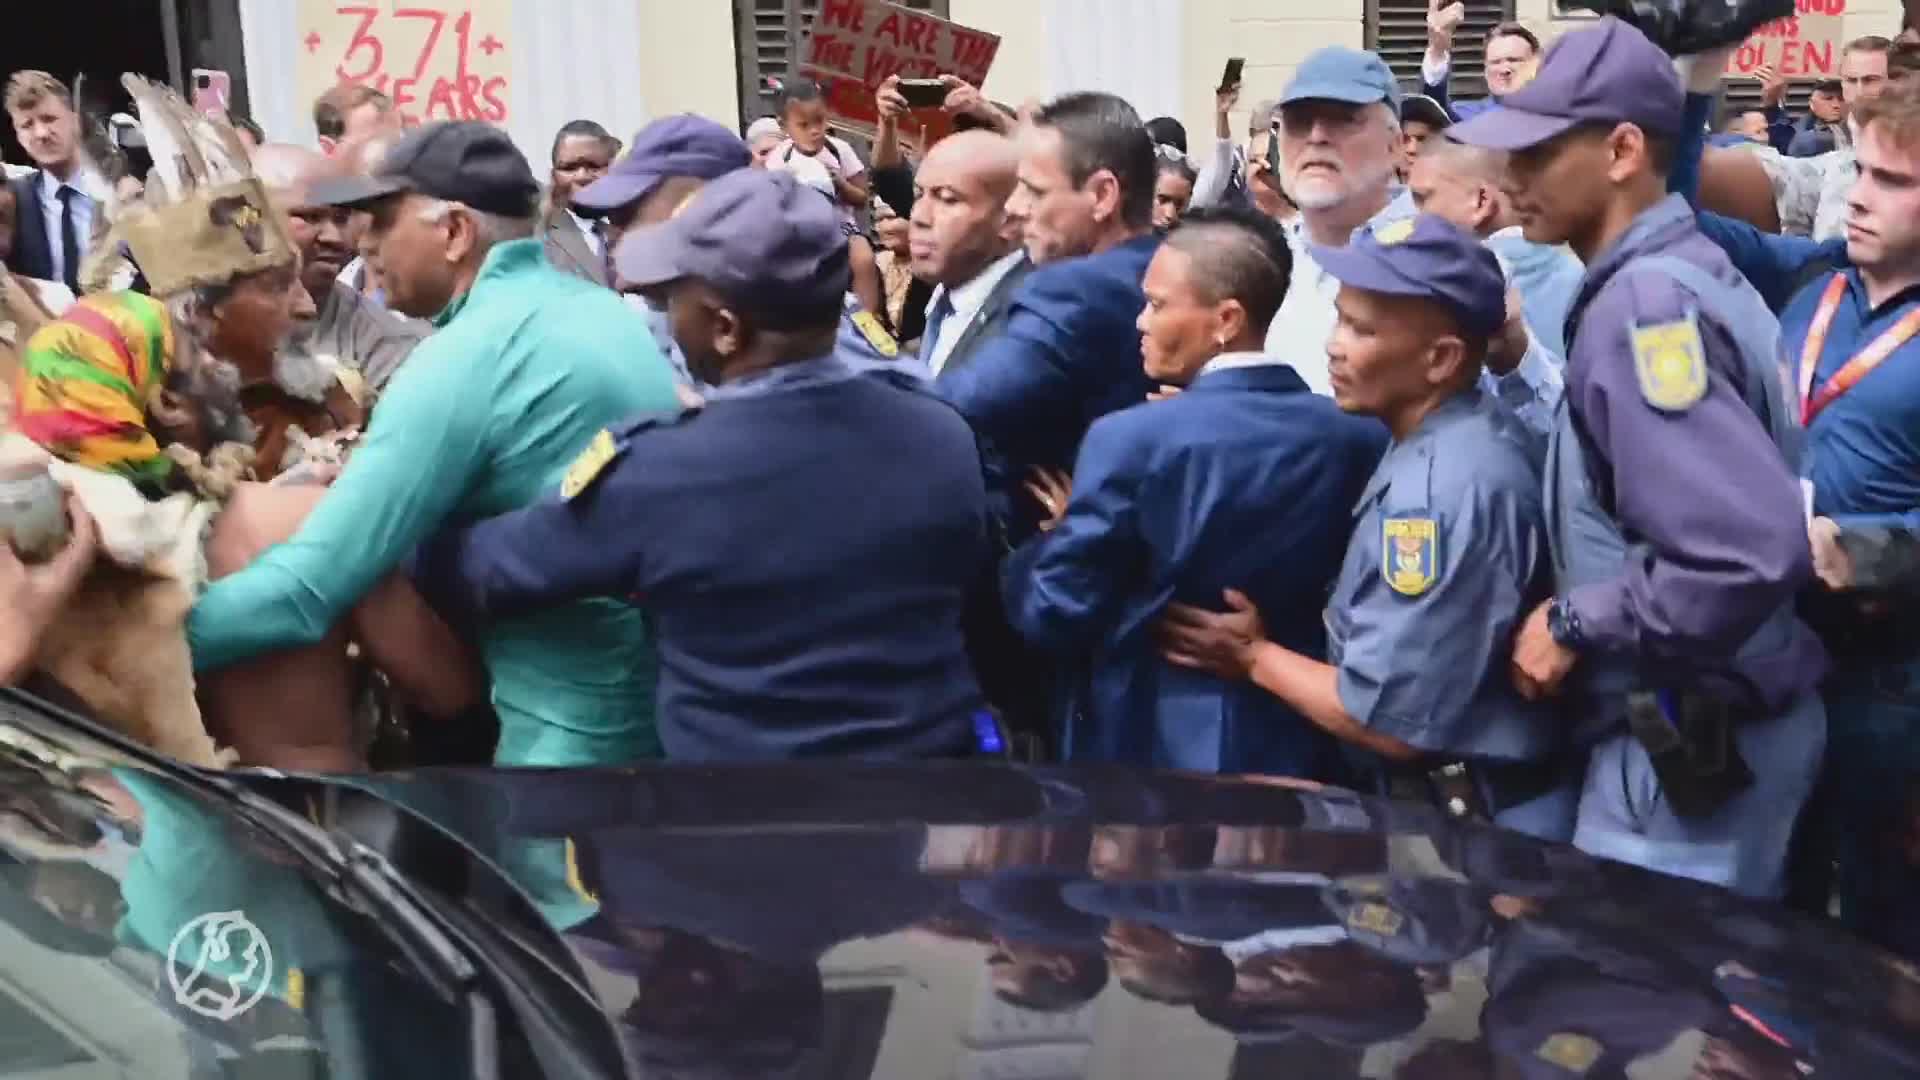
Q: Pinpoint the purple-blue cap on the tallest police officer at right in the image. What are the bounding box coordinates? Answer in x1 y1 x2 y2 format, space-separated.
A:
1448 15 1686 150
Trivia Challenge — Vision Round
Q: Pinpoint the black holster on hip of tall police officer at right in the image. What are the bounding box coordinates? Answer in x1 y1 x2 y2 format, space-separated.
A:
1626 690 1753 817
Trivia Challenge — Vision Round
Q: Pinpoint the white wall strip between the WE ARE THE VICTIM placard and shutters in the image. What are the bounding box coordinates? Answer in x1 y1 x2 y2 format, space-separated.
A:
1044 0 1187 119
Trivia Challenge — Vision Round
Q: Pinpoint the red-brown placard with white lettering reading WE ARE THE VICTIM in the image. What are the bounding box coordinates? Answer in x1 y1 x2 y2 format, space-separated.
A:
801 0 1000 142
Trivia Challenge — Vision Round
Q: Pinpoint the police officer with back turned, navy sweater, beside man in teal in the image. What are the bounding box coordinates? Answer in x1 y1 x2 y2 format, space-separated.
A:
422 169 989 761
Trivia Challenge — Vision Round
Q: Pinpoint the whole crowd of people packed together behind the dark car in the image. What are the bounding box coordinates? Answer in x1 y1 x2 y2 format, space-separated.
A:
0 4 1920 968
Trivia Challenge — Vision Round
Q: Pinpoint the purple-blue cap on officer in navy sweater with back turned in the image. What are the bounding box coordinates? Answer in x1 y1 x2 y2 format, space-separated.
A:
614 169 852 315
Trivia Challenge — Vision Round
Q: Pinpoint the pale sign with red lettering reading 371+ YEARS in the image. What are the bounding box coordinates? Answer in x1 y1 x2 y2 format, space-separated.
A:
294 0 513 123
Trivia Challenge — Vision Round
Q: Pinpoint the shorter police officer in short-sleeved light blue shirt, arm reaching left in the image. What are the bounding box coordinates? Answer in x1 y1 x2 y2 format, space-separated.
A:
1164 213 1578 840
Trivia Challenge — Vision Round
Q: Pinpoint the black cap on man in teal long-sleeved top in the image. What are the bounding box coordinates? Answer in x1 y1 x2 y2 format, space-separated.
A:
311 121 540 217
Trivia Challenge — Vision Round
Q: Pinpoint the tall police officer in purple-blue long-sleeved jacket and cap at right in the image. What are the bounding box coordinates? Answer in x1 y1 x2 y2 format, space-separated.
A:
1450 19 1826 896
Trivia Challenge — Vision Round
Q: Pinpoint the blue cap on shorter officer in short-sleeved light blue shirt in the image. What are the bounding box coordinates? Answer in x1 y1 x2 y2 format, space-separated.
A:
1311 213 1507 336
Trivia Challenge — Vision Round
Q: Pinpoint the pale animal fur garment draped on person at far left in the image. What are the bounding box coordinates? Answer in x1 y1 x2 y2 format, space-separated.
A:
0 432 253 769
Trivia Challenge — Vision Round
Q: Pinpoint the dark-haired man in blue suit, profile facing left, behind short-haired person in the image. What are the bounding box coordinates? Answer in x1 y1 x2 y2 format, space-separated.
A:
937 94 1160 503
